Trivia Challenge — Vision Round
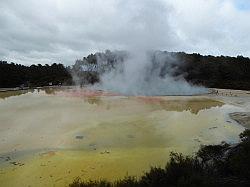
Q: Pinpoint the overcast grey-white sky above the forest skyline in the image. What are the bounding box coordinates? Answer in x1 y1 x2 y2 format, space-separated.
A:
0 0 250 65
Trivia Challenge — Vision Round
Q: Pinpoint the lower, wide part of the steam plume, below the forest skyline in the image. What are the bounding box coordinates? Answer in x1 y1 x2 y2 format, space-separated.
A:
94 51 206 95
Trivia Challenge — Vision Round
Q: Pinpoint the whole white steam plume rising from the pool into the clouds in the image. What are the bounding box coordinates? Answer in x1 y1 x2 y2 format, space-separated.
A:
90 0 206 95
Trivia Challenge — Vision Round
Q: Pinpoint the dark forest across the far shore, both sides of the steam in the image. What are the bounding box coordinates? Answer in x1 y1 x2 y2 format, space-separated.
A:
0 50 250 90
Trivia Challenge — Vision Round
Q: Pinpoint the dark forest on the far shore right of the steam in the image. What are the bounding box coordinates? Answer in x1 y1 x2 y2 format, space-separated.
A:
176 53 250 90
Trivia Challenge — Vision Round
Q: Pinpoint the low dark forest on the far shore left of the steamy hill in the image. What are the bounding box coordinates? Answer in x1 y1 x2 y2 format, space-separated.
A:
0 61 71 88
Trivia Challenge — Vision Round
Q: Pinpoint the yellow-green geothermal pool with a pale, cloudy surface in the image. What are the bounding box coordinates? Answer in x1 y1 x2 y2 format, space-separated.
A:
0 88 250 187
